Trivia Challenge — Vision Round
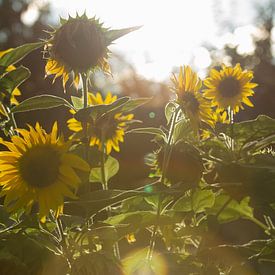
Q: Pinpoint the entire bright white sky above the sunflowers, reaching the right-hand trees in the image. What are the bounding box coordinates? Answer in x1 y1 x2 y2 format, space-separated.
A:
22 0 258 80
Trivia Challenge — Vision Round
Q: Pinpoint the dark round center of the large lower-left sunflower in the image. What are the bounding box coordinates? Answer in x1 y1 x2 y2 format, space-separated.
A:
19 145 60 188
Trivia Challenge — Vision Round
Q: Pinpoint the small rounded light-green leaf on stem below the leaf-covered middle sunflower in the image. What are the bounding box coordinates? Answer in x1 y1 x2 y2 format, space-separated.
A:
90 156 119 183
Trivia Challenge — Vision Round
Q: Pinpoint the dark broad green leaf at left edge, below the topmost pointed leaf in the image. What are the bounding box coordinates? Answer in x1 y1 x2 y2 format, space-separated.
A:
0 66 31 94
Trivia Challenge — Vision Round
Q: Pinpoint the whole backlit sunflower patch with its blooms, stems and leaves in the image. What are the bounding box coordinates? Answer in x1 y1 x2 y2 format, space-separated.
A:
0 11 275 275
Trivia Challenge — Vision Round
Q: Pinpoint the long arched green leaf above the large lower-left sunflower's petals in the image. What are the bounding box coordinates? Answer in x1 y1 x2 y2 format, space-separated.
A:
11 95 74 113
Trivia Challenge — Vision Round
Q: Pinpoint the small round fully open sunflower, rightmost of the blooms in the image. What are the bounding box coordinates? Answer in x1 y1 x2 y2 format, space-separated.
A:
204 64 257 114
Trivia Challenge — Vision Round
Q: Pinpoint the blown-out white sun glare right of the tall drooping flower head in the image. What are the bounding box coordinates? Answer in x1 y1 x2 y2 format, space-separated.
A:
49 0 215 80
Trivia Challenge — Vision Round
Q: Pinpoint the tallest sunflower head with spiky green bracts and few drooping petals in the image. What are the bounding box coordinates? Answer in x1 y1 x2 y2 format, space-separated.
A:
45 14 140 87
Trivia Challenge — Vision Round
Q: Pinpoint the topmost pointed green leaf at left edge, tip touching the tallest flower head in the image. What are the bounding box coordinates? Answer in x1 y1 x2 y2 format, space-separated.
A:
0 42 45 67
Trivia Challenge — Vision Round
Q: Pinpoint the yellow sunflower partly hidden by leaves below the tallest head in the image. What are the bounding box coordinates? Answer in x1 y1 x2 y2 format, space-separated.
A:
67 92 134 154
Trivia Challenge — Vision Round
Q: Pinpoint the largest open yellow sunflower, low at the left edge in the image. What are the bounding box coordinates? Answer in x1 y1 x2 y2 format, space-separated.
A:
0 123 89 222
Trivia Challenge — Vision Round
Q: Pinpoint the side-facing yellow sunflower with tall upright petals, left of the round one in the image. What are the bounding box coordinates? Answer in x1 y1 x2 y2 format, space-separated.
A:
171 66 214 130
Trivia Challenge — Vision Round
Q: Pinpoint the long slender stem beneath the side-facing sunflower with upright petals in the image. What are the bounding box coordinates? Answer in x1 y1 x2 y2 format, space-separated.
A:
146 107 180 262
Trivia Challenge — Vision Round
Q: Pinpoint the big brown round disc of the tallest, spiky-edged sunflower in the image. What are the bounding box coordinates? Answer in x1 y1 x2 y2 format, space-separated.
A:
52 19 106 72
